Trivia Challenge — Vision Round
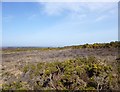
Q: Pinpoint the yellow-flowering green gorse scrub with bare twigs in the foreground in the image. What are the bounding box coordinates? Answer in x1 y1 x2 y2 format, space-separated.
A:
3 57 118 90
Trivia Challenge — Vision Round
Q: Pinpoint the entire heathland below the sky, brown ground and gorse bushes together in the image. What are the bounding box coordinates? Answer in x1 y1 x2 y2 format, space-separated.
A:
0 42 120 91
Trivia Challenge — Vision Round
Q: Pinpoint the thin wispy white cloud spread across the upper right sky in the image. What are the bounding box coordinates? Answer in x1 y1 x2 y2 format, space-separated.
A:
40 2 117 21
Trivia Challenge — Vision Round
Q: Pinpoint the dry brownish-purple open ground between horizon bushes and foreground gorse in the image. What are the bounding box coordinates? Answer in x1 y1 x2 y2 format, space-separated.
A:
0 48 118 90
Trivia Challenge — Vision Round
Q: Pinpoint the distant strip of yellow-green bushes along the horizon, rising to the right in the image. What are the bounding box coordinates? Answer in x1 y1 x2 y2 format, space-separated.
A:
2 41 120 53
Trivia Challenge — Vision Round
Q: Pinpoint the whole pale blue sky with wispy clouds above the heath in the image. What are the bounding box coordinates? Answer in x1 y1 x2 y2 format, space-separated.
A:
2 2 118 47
